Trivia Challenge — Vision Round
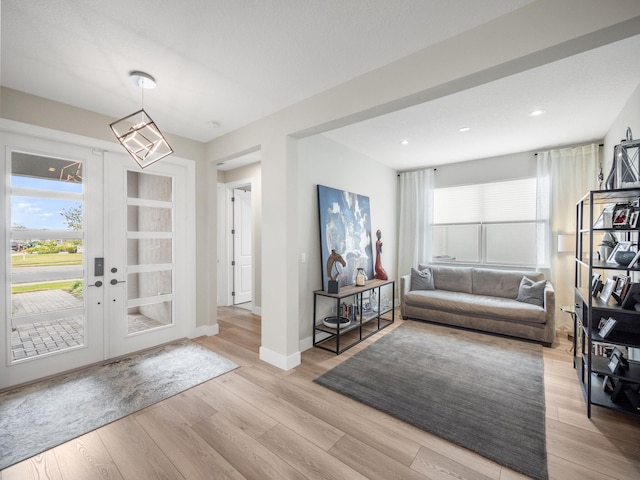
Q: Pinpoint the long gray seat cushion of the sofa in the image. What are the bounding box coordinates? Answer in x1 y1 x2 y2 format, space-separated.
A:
405 289 546 324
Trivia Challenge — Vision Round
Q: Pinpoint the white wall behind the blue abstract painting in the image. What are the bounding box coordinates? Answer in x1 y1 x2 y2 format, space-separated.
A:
292 135 398 350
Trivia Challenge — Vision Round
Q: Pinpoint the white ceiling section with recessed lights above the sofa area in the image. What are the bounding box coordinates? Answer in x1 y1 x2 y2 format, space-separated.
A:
325 35 640 170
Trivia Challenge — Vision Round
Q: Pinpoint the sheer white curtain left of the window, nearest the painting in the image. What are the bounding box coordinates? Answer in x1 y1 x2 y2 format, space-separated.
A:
398 169 435 278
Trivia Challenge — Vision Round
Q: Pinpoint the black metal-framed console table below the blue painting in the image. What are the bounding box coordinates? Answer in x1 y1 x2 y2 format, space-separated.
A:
313 279 395 355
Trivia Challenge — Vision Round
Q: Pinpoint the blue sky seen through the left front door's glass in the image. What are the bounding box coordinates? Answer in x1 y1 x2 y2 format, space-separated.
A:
11 175 82 230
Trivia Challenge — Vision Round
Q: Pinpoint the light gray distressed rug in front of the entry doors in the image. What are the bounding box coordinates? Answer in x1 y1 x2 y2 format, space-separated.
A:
0 341 238 470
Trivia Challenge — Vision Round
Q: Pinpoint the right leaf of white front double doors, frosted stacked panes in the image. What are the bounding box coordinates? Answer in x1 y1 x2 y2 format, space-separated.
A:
105 153 193 358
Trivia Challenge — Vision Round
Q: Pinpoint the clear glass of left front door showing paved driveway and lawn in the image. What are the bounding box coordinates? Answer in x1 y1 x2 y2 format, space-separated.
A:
9 151 86 362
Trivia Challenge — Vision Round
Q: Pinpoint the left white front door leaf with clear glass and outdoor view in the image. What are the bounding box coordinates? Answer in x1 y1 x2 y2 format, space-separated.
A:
0 132 104 388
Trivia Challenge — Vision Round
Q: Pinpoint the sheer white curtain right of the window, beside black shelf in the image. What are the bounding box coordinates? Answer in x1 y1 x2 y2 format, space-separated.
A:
537 144 600 332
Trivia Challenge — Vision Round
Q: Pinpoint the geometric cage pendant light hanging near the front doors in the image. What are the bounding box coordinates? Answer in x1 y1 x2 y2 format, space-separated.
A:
109 72 173 168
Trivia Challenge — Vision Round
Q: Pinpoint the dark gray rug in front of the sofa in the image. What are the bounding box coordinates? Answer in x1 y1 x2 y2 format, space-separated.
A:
315 322 548 480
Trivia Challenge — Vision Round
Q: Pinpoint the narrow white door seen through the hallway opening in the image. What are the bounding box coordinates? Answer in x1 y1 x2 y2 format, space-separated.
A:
233 189 253 305
